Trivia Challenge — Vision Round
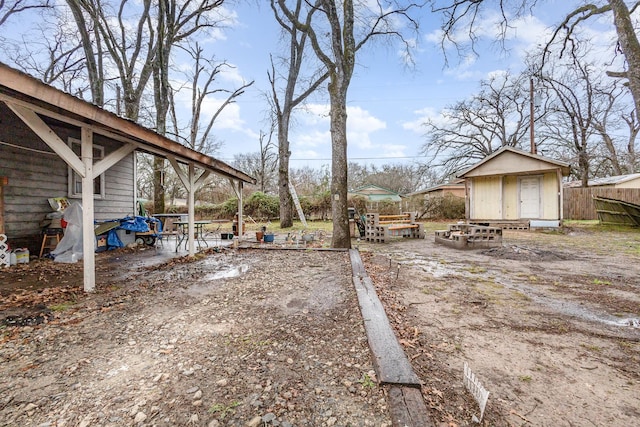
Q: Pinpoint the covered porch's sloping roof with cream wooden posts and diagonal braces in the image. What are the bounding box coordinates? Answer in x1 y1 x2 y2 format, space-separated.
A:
0 64 255 292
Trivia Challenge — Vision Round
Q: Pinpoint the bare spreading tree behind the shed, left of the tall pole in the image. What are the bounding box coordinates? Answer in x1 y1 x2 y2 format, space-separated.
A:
421 73 530 177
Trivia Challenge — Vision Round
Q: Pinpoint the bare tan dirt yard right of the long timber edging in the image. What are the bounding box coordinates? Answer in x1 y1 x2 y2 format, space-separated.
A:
360 229 640 426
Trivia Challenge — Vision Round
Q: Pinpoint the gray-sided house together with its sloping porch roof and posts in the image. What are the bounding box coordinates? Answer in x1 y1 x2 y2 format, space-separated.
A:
0 63 255 291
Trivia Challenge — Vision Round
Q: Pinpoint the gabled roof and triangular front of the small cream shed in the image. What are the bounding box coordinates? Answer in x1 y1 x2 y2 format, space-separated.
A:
458 147 569 178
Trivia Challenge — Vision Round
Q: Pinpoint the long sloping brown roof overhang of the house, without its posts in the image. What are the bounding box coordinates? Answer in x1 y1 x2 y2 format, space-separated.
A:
0 63 256 184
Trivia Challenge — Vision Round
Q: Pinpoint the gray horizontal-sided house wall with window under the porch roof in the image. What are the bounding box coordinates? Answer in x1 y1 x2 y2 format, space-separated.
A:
0 102 136 247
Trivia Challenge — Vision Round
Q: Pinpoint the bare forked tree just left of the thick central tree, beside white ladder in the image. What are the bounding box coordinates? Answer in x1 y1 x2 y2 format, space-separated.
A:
268 0 329 228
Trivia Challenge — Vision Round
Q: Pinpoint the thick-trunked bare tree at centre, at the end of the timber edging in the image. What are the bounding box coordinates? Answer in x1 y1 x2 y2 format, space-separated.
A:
278 0 420 248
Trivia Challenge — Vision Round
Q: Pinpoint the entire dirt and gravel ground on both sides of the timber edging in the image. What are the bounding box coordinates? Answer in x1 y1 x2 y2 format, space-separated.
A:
0 229 640 427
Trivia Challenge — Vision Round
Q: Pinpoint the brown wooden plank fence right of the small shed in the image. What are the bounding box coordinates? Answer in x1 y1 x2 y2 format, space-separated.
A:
563 187 640 219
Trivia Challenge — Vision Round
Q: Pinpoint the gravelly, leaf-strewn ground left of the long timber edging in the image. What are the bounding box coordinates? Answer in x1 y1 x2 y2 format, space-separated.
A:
0 249 391 427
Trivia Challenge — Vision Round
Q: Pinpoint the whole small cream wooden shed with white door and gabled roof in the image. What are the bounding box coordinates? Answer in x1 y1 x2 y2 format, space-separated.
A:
458 147 569 228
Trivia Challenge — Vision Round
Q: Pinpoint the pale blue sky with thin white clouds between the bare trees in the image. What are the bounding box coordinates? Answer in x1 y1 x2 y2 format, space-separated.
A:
0 0 612 169
